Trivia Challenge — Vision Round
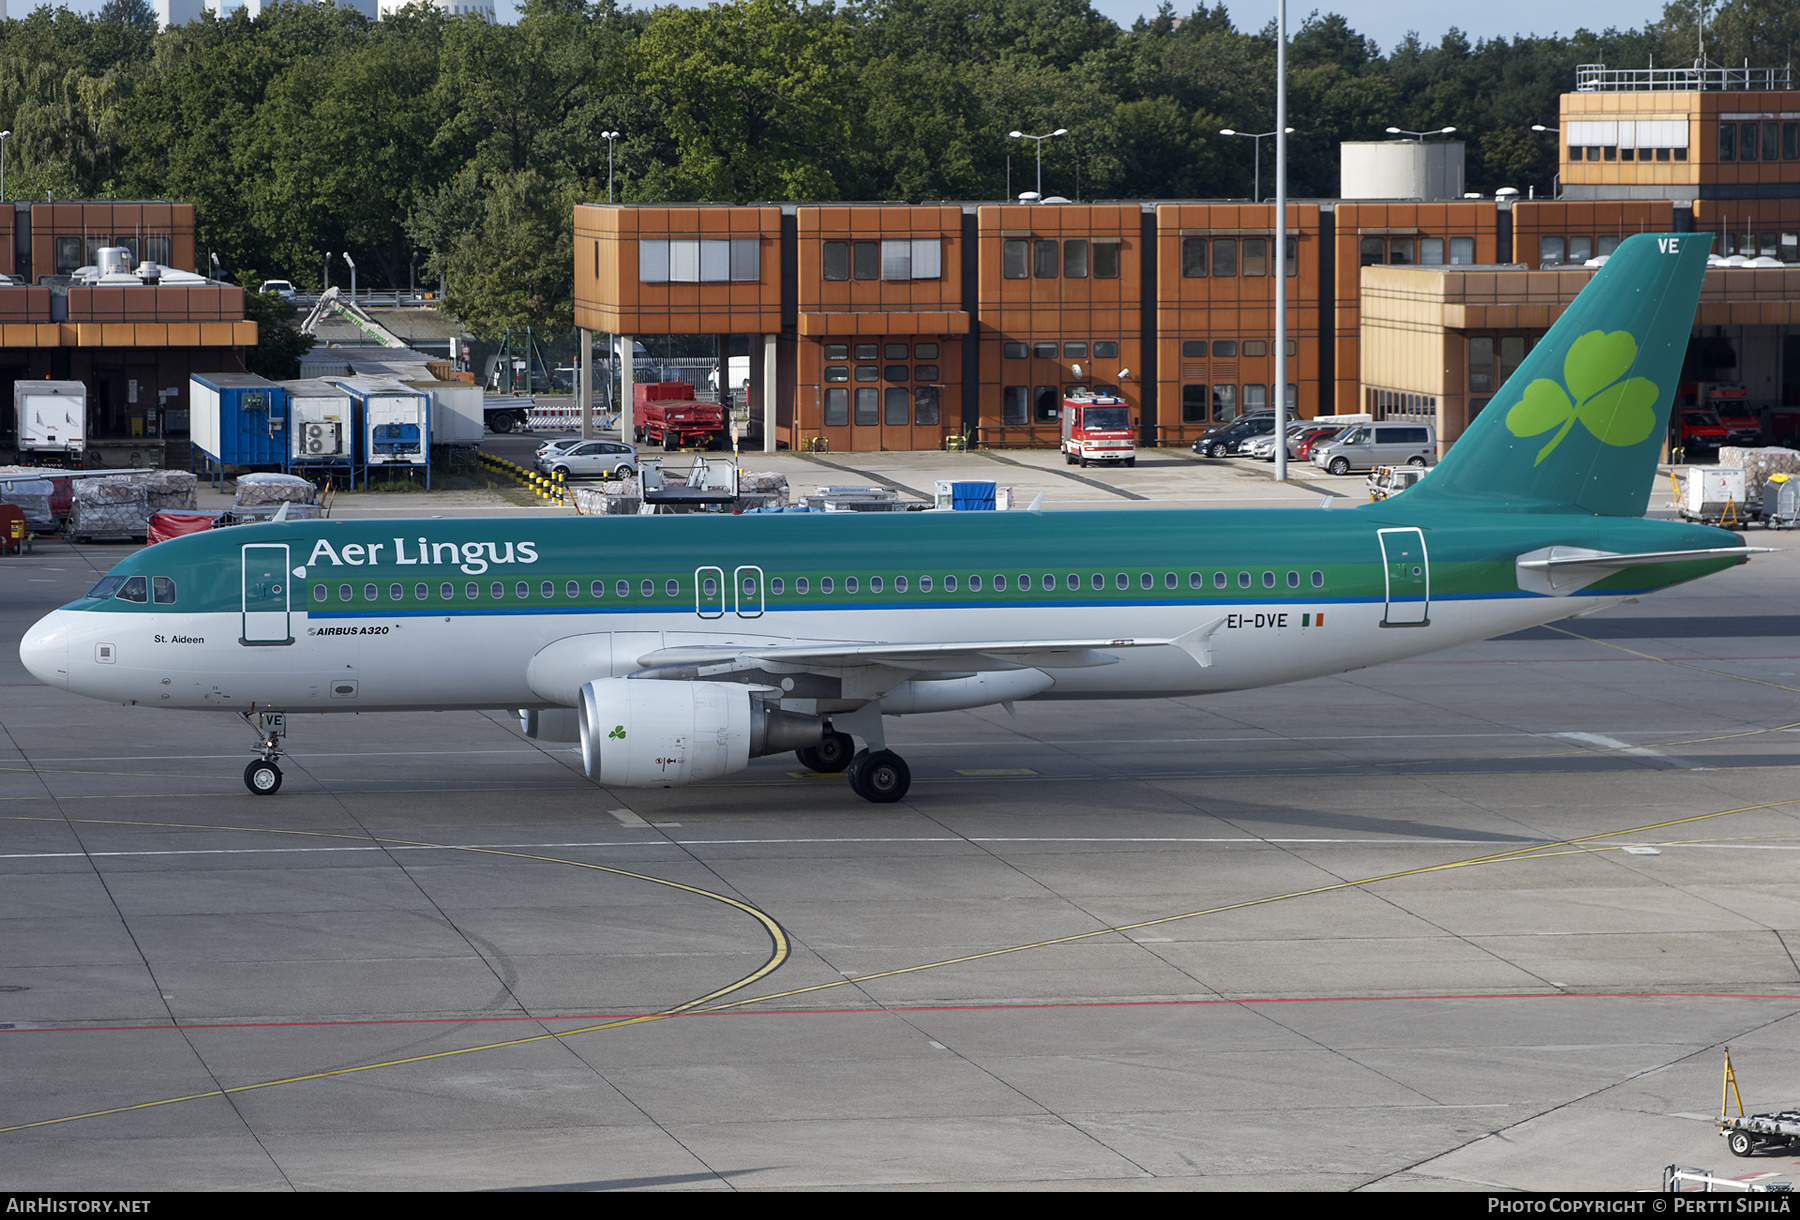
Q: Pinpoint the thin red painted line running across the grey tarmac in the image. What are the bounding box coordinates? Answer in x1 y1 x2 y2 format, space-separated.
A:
0 991 1800 1033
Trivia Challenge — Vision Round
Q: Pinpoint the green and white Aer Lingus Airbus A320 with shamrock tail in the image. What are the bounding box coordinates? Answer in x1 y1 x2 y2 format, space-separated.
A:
20 234 1751 801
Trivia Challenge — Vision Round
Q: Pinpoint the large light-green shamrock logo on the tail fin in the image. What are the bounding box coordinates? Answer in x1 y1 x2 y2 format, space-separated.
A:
1507 331 1661 466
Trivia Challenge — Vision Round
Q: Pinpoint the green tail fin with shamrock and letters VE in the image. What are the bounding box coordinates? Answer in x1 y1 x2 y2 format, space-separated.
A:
1406 234 1712 516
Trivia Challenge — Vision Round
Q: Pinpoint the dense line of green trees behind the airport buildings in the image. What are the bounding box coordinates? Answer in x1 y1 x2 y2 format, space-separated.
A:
0 0 1800 336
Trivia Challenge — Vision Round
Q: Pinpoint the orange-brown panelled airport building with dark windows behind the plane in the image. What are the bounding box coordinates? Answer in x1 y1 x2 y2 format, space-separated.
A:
574 67 1800 452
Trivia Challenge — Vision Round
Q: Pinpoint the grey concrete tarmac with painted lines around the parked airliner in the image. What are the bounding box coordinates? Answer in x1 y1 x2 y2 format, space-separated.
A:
0 449 1800 1191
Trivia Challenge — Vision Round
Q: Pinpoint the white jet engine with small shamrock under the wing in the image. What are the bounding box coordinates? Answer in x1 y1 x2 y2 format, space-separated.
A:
576 678 824 788
